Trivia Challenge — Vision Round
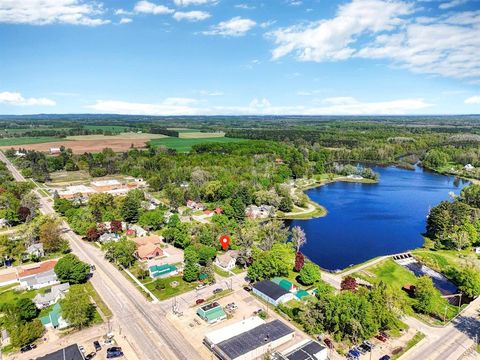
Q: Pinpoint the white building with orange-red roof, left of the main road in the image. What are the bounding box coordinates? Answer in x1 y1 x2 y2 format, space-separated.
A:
18 260 59 290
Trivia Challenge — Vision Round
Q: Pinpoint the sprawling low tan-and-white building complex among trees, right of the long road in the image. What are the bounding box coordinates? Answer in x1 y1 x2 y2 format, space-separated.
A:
58 178 146 200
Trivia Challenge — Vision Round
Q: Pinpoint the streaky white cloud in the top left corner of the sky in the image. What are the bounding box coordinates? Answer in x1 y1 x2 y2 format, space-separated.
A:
0 0 110 26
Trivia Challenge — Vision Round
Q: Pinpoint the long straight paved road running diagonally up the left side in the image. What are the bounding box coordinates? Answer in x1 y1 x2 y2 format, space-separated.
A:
0 152 201 360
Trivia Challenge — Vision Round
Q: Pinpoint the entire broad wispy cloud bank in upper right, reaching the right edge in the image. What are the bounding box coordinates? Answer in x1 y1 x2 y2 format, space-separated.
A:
269 0 480 80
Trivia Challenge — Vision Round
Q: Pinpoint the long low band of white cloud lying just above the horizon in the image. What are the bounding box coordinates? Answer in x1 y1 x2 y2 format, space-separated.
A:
87 97 433 115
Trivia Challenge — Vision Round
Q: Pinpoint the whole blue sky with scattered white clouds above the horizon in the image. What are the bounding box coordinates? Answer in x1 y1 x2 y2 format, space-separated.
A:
0 0 480 115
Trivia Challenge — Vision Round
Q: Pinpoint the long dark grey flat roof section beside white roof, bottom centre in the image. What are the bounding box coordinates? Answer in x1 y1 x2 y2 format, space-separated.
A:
217 319 295 359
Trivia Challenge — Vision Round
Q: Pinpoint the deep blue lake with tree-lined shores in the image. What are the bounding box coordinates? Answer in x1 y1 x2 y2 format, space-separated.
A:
290 166 469 270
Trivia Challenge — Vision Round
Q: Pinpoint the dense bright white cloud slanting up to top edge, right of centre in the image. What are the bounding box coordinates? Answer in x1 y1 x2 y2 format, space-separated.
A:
270 0 412 61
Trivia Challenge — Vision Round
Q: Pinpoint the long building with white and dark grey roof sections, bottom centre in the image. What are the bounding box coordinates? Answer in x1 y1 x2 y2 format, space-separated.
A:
203 318 294 360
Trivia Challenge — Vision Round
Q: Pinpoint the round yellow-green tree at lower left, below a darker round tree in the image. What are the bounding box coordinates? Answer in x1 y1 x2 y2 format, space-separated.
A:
60 285 95 329
